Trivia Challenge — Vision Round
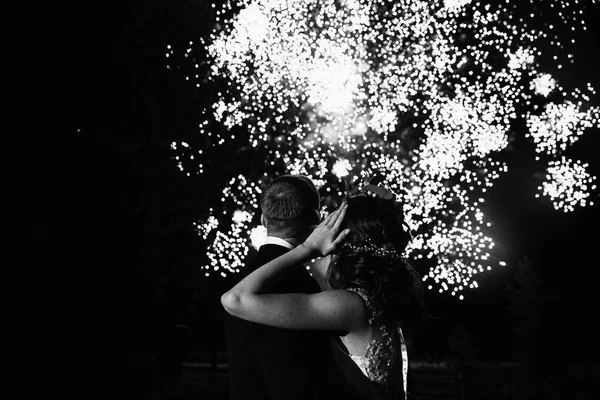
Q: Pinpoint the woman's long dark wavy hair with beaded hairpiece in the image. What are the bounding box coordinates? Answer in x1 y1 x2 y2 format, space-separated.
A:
327 195 426 321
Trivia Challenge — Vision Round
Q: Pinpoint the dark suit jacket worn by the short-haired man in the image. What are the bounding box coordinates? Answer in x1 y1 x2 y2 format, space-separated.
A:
225 244 366 400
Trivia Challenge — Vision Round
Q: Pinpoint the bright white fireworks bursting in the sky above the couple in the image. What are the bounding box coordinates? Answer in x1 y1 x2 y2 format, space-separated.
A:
167 0 599 298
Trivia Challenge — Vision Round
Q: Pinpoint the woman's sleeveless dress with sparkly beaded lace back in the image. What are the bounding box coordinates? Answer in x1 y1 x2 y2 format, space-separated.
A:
340 288 408 400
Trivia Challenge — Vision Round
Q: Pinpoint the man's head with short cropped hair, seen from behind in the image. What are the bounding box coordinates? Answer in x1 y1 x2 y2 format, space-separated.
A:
260 175 321 240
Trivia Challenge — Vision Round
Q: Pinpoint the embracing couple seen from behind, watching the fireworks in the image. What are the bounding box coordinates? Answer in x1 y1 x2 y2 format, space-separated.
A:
221 175 425 400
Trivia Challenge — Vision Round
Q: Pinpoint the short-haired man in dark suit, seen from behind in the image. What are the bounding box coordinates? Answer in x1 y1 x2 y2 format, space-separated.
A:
225 175 331 400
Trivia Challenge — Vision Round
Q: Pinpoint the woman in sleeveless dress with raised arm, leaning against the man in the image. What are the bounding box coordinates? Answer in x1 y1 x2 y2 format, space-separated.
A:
221 180 424 399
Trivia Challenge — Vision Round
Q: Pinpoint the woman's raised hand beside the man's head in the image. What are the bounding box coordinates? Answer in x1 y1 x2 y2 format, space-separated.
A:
302 202 350 256
